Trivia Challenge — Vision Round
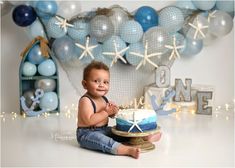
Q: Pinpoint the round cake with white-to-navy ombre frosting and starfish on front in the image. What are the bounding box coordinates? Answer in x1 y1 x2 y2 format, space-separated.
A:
116 109 157 132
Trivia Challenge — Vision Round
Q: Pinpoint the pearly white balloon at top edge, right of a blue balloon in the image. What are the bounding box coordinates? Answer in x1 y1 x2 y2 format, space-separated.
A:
57 1 81 19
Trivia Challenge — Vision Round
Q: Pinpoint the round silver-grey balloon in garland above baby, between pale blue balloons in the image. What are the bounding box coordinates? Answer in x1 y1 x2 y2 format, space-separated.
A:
90 15 114 42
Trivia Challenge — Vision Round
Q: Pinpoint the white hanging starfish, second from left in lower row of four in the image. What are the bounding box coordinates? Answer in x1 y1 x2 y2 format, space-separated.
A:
102 40 129 67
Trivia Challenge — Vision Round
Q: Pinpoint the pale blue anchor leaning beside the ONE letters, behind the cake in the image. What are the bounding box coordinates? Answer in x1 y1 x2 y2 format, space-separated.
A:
148 88 176 115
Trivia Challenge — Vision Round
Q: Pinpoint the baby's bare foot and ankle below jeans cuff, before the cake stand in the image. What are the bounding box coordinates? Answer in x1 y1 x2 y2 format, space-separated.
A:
117 144 140 159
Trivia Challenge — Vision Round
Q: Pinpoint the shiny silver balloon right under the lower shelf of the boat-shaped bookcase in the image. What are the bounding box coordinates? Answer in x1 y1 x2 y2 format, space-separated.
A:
34 79 56 92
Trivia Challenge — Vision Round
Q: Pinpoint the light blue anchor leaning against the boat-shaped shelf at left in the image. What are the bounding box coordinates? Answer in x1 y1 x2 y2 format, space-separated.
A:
20 89 46 117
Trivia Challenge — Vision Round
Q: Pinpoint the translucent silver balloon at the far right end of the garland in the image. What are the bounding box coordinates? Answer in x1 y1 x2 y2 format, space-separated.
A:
209 11 233 37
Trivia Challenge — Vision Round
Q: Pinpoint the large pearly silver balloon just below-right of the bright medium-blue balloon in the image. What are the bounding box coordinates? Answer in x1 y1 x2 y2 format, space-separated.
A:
143 26 171 53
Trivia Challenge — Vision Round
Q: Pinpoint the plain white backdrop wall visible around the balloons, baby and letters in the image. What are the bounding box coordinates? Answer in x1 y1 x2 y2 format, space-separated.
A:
1 0 234 112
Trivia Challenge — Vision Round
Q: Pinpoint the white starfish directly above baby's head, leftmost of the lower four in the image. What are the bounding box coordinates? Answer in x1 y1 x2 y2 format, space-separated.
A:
75 37 98 59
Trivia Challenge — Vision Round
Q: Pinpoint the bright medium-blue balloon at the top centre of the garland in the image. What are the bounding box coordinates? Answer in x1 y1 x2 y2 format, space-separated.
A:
134 6 158 32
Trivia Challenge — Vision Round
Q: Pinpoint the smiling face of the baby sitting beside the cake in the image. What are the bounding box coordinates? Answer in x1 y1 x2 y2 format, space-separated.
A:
85 69 110 97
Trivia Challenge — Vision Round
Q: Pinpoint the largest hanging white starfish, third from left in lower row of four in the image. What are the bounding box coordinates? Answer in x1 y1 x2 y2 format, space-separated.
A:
130 41 162 70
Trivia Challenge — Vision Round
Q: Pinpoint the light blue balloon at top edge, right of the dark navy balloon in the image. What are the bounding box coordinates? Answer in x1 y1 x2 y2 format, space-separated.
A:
35 1 58 19
